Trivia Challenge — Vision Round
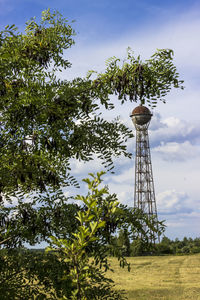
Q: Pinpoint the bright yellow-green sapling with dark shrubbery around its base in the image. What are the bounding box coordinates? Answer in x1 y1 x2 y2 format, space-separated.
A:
0 173 162 300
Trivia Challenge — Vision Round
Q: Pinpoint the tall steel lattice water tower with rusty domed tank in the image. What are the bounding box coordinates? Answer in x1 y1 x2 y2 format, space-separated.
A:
131 105 159 244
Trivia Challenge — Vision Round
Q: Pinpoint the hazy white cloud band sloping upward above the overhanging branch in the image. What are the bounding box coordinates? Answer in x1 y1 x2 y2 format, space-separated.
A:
63 7 200 75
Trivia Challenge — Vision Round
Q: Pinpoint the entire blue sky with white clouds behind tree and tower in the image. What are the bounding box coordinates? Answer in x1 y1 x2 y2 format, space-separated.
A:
0 0 200 239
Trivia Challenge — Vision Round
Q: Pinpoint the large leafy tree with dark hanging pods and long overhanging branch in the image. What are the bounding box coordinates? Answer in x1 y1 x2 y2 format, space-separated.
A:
0 10 182 298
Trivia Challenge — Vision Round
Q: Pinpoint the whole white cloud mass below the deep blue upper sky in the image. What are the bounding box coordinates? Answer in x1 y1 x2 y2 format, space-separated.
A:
59 9 200 238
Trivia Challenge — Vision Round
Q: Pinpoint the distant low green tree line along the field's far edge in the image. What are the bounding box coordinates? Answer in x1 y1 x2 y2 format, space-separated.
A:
111 229 200 256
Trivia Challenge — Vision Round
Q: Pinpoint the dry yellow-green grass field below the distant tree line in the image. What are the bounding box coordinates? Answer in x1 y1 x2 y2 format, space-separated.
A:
108 254 200 300
